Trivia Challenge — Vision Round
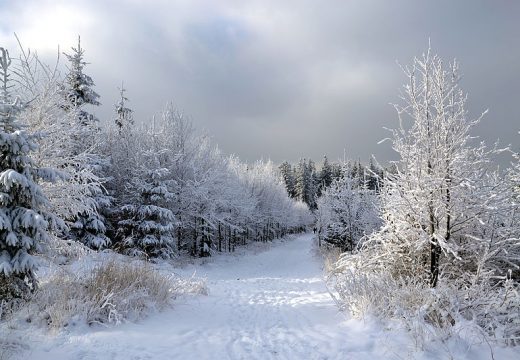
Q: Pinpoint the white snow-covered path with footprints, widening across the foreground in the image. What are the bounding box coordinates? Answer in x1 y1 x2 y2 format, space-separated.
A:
12 234 520 360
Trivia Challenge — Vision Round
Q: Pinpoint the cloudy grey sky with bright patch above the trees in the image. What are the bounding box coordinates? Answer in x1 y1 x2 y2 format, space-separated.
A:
0 0 520 163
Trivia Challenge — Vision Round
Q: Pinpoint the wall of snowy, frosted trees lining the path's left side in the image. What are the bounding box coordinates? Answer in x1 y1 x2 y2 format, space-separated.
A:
0 41 312 297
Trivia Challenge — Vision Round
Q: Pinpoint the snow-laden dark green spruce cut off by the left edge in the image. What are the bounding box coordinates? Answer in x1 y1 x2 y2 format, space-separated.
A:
0 48 56 298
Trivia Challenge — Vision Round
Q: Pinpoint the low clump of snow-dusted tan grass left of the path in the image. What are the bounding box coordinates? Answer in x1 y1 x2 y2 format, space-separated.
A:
26 259 184 329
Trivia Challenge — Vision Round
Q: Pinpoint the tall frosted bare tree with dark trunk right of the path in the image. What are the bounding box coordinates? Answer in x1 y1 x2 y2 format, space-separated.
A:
364 51 516 287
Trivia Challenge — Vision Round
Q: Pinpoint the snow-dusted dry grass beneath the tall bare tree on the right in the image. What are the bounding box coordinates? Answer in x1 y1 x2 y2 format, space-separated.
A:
329 260 520 347
